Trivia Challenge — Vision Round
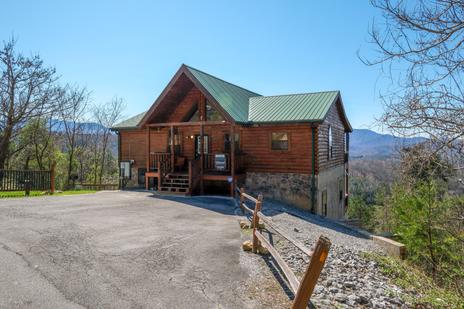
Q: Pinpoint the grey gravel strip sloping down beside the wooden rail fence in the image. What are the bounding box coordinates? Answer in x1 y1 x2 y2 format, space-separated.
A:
237 200 410 308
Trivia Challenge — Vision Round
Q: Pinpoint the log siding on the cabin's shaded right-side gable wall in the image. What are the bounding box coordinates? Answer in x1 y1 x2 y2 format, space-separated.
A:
316 104 345 170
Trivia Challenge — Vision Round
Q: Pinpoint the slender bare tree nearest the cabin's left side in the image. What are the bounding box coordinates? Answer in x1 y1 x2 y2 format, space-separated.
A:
94 97 125 183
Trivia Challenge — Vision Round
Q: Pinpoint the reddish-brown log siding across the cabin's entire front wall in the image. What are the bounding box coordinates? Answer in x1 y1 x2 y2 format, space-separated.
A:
120 124 316 174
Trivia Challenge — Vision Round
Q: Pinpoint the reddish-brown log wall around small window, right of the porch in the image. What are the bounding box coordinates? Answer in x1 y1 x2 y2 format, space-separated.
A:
240 124 312 174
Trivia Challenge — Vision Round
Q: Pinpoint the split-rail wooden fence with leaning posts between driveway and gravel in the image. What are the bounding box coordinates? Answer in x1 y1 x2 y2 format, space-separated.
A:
236 188 331 309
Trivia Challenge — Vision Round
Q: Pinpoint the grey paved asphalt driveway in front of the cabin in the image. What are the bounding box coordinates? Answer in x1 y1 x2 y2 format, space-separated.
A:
0 192 250 308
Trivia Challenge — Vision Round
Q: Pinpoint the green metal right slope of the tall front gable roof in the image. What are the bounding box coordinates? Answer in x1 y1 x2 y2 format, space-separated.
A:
186 66 260 122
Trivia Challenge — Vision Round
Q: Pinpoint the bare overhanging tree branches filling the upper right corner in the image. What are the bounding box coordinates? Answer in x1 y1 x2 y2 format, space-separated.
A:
361 0 464 156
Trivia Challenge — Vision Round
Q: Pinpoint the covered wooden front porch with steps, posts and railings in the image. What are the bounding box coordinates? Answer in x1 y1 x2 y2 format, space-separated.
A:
145 121 245 196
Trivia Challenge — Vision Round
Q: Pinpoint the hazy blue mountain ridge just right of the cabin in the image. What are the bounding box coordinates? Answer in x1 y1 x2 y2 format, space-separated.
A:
350 129 427 159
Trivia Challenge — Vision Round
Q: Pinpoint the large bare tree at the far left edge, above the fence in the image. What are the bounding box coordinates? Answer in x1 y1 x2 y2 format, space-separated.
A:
0 39 58 168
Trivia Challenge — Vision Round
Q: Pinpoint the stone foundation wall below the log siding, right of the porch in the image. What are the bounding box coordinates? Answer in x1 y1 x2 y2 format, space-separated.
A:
245 172 311 210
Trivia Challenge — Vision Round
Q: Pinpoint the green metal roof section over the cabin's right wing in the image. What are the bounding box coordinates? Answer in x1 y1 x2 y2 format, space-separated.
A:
248 91 339 123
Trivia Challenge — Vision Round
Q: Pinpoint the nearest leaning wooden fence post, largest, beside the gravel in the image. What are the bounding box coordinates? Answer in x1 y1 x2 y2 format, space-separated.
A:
292 235 331 309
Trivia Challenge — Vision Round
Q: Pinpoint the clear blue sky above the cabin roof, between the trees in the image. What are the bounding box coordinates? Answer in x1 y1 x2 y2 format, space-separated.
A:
0 0 385 128
